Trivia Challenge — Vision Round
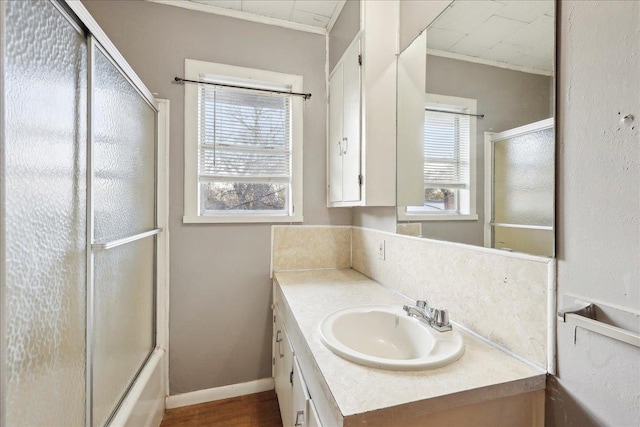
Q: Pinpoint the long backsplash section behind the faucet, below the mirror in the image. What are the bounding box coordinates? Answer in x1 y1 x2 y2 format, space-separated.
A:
352 228 555 369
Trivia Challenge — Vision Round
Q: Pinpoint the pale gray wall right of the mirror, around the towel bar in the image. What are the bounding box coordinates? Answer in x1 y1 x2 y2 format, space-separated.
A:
546 0 640 427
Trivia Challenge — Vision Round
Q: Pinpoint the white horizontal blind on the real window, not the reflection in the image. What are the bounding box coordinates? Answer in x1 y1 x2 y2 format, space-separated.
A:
198 85 291 183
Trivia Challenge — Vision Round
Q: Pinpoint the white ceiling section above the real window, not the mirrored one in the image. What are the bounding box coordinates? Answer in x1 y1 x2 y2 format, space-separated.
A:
148 0 345 32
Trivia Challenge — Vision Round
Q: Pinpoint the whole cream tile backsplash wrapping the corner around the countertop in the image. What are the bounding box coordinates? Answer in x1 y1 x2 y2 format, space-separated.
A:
272 226 555 372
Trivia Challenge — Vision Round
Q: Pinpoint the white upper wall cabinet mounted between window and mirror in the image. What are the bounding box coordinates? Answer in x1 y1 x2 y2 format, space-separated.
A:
327 0 397 207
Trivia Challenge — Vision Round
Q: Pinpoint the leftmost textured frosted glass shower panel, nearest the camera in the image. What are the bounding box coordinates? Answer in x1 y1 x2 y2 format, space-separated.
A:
0 0 87 426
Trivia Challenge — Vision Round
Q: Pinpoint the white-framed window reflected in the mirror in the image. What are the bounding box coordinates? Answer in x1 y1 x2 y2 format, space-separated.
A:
400 95 477 220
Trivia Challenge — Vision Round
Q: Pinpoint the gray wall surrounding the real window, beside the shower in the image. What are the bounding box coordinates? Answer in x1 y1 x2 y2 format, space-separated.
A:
84 1 352 394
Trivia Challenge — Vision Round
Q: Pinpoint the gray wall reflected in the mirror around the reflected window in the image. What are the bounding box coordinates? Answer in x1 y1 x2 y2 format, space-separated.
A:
422 55 553 246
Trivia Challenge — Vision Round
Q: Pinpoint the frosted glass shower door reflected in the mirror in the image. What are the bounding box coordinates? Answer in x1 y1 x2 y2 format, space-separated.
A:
491 119 555 256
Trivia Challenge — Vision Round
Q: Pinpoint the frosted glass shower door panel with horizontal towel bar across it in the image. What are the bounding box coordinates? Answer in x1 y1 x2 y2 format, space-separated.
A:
90 40 157 426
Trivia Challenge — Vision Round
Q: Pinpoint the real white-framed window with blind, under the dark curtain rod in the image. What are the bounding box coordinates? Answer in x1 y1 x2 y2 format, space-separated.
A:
184 59 303 222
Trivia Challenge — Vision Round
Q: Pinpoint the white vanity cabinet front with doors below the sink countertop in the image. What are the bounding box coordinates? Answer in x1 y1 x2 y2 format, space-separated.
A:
272 304 322 427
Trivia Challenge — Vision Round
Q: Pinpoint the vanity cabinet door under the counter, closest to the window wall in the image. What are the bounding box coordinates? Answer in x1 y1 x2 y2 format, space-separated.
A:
273 307 293 426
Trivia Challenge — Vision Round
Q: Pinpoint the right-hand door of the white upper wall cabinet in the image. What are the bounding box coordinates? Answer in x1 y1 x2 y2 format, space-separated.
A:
341 40 360 202
